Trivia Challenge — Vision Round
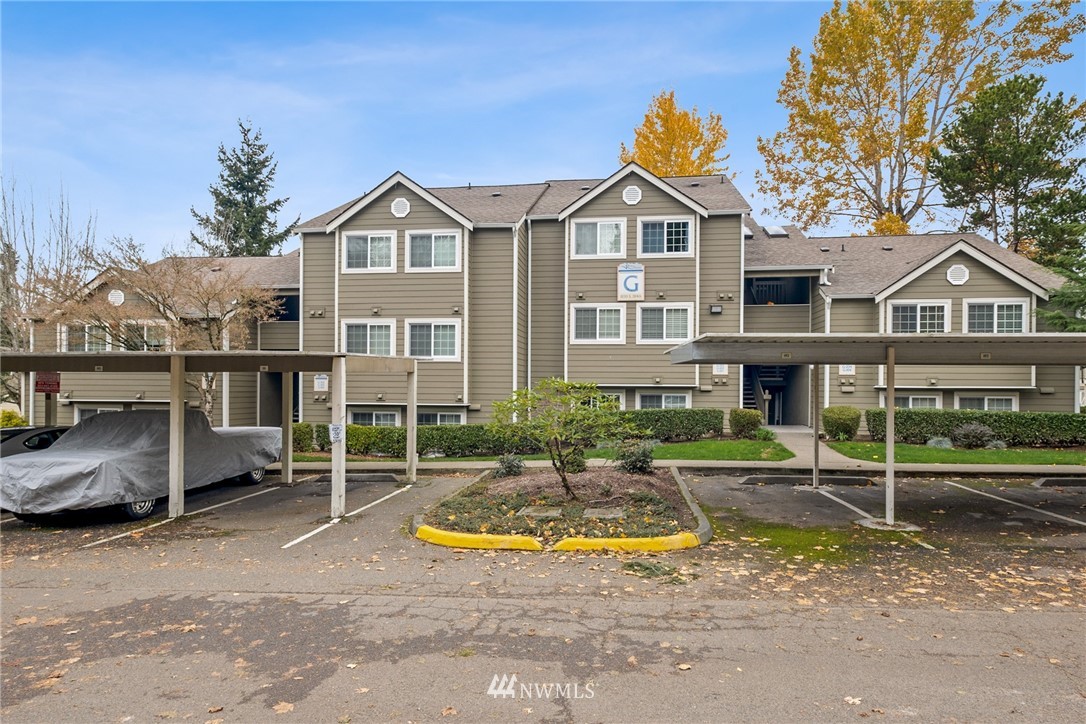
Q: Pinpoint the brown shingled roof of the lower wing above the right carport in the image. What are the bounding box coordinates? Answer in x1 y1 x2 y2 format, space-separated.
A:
746 229 1063 299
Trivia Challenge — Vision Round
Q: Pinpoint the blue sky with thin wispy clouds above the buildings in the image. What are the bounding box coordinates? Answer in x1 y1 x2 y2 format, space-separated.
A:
0 1 1086 253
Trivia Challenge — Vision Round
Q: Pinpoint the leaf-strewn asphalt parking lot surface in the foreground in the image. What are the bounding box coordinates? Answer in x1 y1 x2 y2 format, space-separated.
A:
0 475 1086 722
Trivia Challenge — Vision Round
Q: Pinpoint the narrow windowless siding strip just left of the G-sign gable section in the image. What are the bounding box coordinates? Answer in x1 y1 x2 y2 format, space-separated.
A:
530 221 564 384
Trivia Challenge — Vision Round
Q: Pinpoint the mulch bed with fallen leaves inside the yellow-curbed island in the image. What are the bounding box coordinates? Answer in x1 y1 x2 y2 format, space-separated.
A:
425 468 697 541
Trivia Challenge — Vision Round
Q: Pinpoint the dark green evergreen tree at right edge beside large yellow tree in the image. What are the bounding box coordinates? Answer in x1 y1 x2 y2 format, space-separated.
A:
930 75 1086 256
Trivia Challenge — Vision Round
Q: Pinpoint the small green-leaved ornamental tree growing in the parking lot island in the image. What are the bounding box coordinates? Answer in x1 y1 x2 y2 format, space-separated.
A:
492 377 643 499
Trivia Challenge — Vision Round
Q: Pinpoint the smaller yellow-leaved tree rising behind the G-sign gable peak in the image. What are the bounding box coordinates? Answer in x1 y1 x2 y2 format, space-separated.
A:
618 90 728 177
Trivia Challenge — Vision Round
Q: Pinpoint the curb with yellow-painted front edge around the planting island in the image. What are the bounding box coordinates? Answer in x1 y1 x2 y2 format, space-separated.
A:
411 466 712 552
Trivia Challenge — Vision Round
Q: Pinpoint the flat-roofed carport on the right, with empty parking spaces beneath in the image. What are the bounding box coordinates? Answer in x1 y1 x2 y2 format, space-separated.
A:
668 333 1086 526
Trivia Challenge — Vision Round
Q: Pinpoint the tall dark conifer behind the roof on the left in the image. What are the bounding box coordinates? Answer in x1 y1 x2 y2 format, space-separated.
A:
190 118 300 256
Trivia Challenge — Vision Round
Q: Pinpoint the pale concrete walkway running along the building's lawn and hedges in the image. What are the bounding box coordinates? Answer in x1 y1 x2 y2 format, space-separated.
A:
268 425 1086 478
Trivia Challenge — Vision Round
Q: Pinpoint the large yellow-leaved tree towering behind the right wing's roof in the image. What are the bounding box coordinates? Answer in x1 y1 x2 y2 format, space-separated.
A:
757 0 1086 233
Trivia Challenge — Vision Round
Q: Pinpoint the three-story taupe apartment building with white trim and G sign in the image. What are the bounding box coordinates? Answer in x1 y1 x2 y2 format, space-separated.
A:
25 164 1086 425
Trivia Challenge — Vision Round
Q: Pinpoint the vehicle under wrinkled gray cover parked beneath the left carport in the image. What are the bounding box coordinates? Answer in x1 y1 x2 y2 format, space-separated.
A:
0 410 282 513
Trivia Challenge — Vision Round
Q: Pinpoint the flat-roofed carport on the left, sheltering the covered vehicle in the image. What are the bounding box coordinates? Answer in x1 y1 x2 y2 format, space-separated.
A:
0 351 418 519
